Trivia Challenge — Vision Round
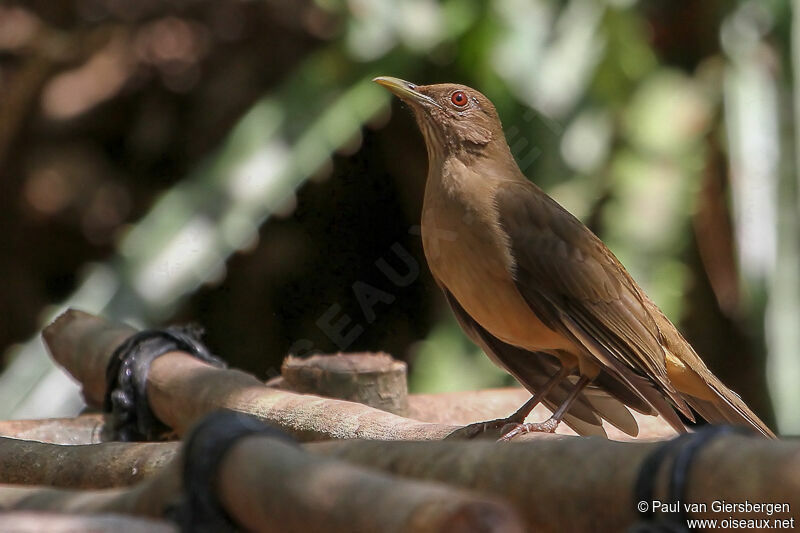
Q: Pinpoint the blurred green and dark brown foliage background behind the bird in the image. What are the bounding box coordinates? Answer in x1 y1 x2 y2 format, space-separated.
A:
0 0 800 434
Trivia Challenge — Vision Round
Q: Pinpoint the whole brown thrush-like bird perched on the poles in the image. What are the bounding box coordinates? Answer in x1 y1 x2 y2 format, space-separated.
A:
373 76 775 440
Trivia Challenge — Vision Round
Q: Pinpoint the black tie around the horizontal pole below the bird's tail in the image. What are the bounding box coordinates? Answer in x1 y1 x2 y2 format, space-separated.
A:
628 425 752 533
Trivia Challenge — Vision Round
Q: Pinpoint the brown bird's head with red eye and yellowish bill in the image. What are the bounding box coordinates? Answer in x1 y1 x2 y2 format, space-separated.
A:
373 76 507 159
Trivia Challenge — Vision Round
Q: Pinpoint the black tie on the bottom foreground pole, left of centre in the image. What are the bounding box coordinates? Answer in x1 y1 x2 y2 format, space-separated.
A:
167 410 297 533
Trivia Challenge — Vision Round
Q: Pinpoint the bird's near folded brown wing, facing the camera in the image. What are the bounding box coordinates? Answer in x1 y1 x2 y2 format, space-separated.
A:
494 181 693 431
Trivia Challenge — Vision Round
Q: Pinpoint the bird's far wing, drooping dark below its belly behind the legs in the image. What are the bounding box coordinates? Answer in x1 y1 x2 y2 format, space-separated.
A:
437 280 651 437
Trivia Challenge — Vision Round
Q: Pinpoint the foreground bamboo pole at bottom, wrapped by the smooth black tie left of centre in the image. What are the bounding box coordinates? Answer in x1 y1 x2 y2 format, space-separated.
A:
0 435 523 533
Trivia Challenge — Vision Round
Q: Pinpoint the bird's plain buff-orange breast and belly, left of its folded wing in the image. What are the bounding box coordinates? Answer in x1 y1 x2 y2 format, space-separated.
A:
422 183 572 351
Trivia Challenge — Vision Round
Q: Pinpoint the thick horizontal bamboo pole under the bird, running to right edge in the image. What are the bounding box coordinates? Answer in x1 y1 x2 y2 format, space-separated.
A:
307 436 800 532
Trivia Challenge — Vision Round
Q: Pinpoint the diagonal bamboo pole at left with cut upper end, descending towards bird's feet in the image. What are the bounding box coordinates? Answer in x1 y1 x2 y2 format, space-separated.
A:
43 310 457 440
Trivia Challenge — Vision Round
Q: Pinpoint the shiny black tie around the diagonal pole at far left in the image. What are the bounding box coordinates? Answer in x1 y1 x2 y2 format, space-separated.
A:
103 325 226 442
